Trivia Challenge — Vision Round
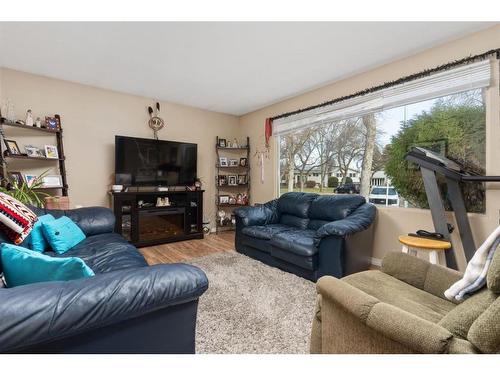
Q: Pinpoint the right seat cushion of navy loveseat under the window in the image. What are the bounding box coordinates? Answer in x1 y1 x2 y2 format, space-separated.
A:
271 229 318 257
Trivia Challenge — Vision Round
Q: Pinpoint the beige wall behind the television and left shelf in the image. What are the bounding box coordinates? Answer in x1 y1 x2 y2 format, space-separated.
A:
0 69 239 226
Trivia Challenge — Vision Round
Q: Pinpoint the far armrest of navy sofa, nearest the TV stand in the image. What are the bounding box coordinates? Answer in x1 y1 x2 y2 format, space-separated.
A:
34 206 115 237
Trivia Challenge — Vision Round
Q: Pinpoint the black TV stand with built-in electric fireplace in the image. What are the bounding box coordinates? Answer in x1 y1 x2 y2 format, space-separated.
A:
111 189 204 247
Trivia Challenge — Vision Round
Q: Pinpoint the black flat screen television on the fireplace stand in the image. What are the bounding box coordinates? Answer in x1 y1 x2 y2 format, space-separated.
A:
115 135 198 186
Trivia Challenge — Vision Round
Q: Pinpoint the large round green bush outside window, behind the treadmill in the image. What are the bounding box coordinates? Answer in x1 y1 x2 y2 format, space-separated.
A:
384 92 486 212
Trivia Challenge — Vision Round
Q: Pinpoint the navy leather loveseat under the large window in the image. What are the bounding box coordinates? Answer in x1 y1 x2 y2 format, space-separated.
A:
235 192 376 281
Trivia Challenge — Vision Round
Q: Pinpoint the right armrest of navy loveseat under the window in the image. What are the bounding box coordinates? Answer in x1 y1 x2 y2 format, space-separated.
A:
316 203 377 240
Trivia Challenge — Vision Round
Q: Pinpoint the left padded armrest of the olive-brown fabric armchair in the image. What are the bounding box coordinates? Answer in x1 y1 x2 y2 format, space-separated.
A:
317 276 453 353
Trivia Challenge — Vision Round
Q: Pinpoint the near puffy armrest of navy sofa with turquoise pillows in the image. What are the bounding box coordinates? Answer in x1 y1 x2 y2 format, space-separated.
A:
0 264 208 352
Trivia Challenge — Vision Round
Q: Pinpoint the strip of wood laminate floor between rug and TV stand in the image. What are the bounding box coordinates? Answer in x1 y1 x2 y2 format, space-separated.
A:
139 232 235 265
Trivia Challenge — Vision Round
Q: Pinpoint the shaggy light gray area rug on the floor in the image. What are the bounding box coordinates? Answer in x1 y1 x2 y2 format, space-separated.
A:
189 252 316 354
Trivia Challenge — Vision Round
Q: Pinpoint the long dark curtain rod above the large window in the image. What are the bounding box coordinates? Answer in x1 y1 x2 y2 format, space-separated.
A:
271 48 500 121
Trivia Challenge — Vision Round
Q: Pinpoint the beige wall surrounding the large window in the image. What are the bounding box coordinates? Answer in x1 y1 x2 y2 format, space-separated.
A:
240 26 500 266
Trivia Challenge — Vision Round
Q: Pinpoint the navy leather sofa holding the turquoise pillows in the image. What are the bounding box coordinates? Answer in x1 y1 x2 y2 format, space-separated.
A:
0 207 208 353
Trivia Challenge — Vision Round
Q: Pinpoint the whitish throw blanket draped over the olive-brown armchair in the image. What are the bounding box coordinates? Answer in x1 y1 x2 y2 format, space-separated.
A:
444 226 500 301
